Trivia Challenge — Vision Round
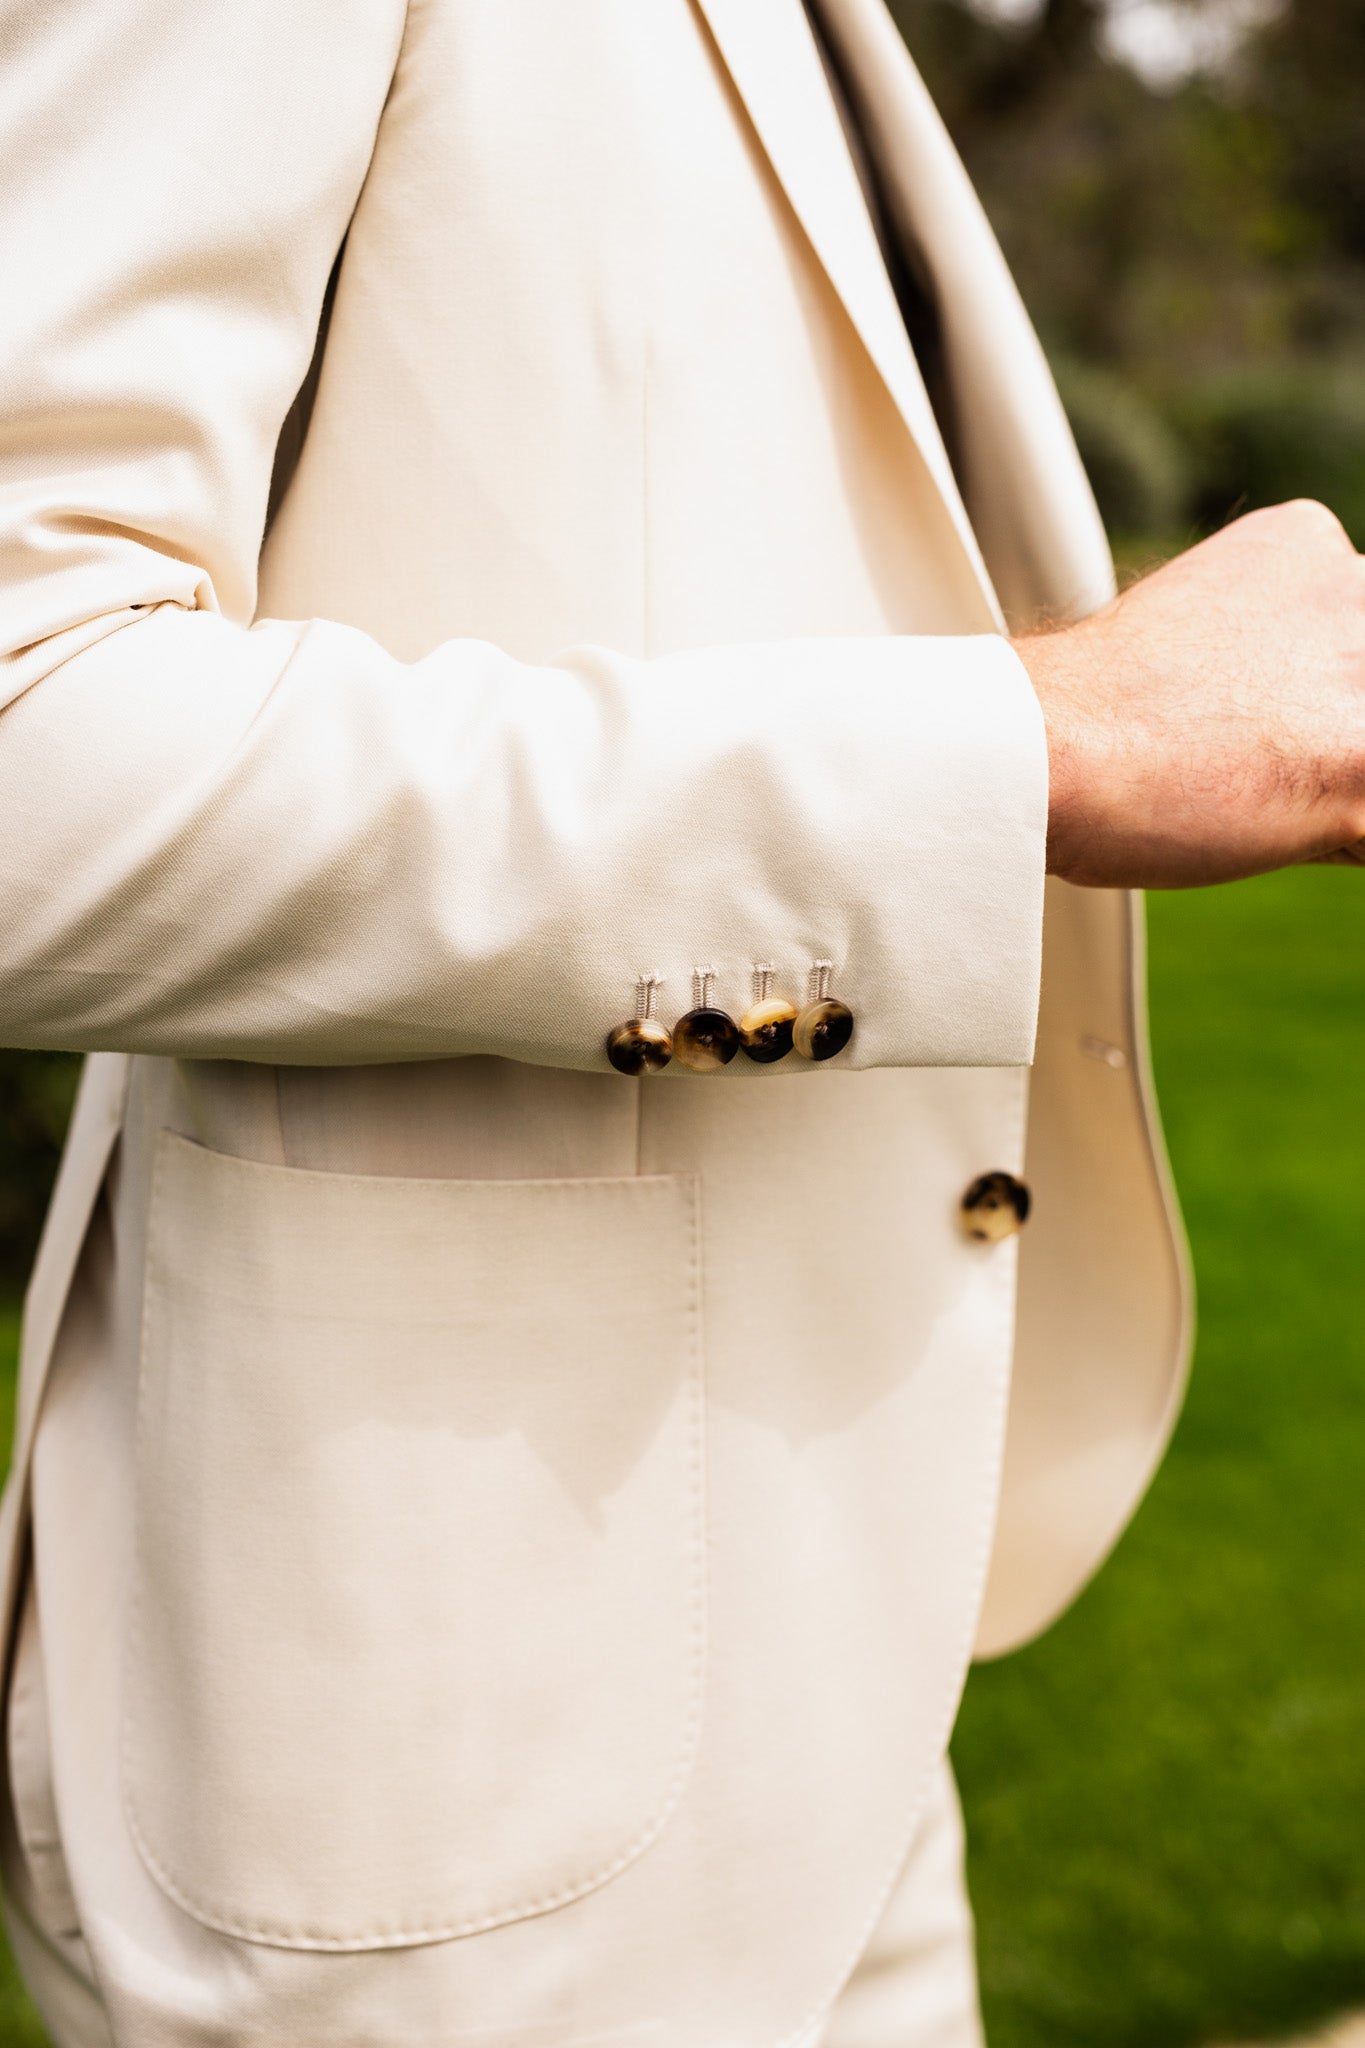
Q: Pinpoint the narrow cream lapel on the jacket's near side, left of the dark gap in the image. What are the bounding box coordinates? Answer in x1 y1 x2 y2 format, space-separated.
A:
696 0 999 621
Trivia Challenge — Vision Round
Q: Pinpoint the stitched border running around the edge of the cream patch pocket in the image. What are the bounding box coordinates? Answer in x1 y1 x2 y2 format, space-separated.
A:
121 1130 708 1954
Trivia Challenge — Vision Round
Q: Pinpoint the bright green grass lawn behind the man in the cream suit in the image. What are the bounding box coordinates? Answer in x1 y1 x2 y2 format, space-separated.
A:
0 870 1365 2048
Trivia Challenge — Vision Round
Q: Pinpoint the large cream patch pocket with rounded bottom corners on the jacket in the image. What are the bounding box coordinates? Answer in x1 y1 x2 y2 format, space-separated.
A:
123 1133 704 1950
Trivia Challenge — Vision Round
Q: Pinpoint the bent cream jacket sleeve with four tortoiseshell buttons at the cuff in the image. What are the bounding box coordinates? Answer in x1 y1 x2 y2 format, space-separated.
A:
0 0 1046 1073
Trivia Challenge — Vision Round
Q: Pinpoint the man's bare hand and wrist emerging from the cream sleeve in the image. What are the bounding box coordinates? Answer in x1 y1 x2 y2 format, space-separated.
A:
1015 502 1365 889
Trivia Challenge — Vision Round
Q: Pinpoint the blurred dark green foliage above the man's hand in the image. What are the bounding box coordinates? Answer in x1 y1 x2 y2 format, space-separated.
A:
892 0 1365 547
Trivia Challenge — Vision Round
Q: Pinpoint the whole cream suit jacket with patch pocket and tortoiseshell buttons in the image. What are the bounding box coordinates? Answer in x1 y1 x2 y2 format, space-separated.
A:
0 0 1185 2048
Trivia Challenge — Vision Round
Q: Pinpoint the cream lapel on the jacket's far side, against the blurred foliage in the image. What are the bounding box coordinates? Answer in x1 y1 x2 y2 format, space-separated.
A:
810 0 1113 623
